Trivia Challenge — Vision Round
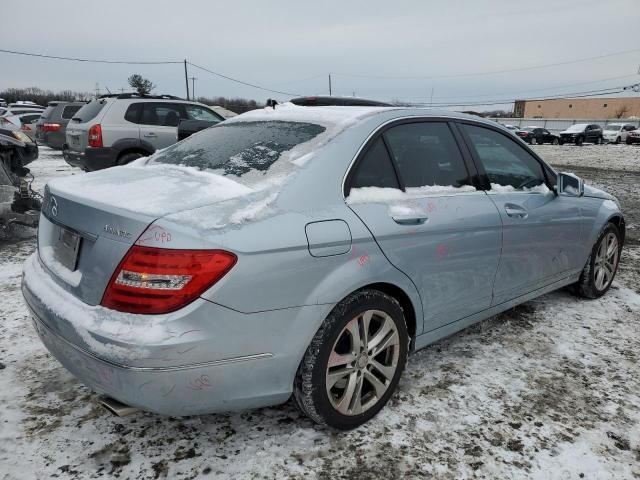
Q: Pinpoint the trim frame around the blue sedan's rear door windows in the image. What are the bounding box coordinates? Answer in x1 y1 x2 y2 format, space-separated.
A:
342 116 479 199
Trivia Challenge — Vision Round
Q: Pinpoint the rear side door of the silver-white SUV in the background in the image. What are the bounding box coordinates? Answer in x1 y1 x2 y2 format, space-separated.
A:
140 102 187 149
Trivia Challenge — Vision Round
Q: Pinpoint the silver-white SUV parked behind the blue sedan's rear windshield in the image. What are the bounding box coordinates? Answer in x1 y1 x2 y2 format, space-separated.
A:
62 93 224 171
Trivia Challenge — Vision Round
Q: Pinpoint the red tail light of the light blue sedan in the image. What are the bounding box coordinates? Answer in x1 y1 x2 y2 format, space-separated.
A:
101 245 237 314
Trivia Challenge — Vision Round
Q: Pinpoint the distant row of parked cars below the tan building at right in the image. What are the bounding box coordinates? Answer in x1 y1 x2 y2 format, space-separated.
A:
503 123 640 145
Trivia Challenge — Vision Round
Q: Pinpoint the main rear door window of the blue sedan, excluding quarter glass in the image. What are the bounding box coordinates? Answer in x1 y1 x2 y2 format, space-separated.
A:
384 122 471 187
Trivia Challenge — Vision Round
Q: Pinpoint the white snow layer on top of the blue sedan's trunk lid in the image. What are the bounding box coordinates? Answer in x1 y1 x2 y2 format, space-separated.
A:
49 164 253 217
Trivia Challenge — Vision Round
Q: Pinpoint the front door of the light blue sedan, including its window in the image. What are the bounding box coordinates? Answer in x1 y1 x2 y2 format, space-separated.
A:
460 124 582 305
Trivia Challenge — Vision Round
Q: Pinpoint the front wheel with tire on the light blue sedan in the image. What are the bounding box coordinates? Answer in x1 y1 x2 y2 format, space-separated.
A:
573 223 622 298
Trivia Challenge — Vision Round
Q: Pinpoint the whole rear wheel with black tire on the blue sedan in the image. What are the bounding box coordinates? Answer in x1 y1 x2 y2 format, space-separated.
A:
293 290 409 430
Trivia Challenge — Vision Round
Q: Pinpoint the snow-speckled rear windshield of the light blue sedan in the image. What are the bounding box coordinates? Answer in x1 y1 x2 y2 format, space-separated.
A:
153 121 326 177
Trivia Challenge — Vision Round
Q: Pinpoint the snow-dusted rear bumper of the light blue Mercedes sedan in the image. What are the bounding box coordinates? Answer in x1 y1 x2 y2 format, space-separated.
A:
22 254 322 416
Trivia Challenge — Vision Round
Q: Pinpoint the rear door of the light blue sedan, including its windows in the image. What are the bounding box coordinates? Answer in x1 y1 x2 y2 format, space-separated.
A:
347 121 501 331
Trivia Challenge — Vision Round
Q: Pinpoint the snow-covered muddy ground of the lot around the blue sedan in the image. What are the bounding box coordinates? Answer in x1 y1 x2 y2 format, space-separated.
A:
0 146 640 480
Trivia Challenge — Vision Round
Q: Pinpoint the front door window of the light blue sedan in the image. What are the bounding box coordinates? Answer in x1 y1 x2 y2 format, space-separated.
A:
461 124 545 191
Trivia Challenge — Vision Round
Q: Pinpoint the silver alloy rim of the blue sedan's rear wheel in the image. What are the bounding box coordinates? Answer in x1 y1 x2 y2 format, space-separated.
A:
326 310 400 416
